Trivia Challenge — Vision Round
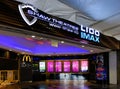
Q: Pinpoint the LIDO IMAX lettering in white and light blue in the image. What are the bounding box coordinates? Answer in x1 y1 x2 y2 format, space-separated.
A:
80 25 100 43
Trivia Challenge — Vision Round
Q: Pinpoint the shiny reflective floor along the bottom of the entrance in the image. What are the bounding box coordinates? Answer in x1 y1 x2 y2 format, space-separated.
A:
0 80 120 89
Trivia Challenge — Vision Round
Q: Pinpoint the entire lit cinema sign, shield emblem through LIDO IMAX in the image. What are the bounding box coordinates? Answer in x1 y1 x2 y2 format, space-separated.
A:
18 4 100 43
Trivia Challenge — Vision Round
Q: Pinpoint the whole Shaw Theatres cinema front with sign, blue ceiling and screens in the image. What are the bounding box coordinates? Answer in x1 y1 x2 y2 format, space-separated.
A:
0 1 120 83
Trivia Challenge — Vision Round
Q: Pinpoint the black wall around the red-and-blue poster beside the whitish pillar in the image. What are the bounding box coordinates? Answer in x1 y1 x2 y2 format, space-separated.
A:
89 52 109 84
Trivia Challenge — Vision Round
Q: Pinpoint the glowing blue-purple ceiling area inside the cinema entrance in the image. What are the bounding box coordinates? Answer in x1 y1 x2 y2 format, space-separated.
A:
0 34 89 55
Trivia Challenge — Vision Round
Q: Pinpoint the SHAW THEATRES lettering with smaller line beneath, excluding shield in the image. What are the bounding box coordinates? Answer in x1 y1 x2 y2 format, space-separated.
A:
27 9 79 34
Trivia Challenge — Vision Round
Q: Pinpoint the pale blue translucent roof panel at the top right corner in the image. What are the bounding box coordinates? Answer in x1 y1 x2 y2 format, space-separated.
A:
59 0 120 20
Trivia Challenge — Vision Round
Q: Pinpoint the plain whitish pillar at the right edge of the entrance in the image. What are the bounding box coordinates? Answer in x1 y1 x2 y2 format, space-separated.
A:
109 51 117 84
